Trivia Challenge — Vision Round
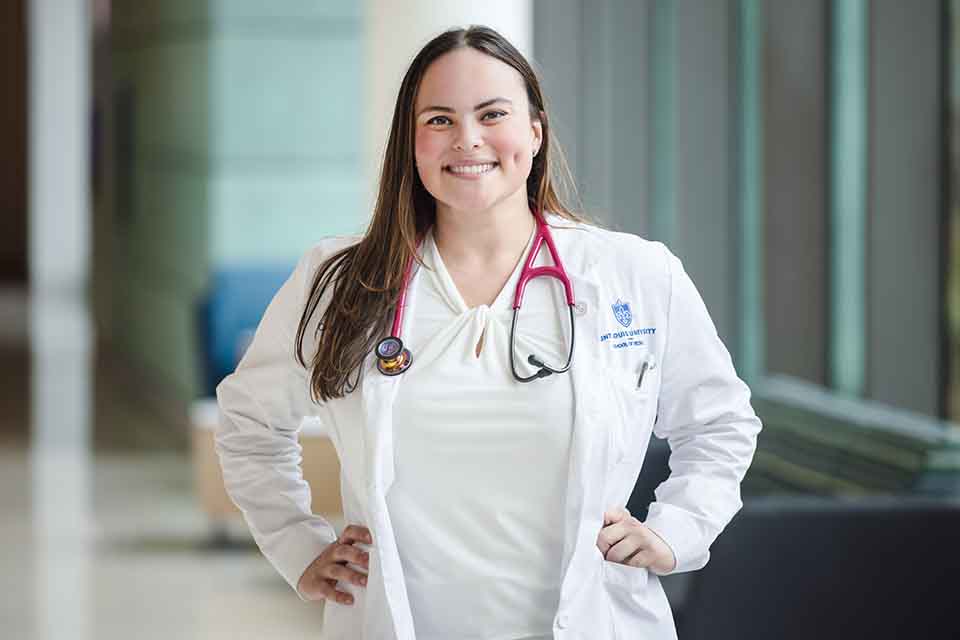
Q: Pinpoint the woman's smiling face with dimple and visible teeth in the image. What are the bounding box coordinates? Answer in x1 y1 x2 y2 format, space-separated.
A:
414 47 542 220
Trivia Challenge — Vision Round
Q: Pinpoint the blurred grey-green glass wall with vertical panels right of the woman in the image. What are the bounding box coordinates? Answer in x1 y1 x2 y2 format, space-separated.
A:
534 0 960 493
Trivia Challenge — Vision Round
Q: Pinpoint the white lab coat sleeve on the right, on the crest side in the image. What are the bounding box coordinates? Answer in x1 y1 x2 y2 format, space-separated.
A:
645 247 761 573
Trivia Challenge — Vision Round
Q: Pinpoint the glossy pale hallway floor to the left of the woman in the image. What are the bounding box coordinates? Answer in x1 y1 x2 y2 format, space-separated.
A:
0 288 332 640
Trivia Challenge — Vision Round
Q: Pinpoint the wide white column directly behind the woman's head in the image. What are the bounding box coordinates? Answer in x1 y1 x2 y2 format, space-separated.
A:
363 0 533 221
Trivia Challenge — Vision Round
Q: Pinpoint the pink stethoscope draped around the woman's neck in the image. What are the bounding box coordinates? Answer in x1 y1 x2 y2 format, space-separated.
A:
376 211 575 382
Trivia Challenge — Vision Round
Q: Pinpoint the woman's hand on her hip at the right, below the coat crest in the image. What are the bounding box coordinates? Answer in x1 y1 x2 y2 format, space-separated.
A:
597 508 677 575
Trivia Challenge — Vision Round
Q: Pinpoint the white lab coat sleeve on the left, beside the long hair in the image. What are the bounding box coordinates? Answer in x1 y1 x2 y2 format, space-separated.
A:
216 253 337 598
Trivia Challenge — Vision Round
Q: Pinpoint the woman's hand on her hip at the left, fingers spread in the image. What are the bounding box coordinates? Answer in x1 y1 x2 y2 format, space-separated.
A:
297 524 373 604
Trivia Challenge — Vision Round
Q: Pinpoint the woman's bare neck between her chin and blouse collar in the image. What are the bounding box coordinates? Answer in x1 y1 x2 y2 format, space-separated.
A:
433 196 536 265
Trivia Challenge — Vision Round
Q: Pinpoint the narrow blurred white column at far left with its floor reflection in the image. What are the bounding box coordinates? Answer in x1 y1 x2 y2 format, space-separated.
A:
27 0 93 640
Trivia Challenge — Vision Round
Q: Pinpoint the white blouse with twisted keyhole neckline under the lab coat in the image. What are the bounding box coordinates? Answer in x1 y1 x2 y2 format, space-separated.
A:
387 222 573 640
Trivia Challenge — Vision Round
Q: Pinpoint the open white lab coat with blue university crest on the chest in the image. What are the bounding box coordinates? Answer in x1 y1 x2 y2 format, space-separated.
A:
216 215 760 640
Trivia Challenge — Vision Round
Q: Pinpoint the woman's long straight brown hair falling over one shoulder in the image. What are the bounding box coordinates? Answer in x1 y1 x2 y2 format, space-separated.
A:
296 26 586 401
